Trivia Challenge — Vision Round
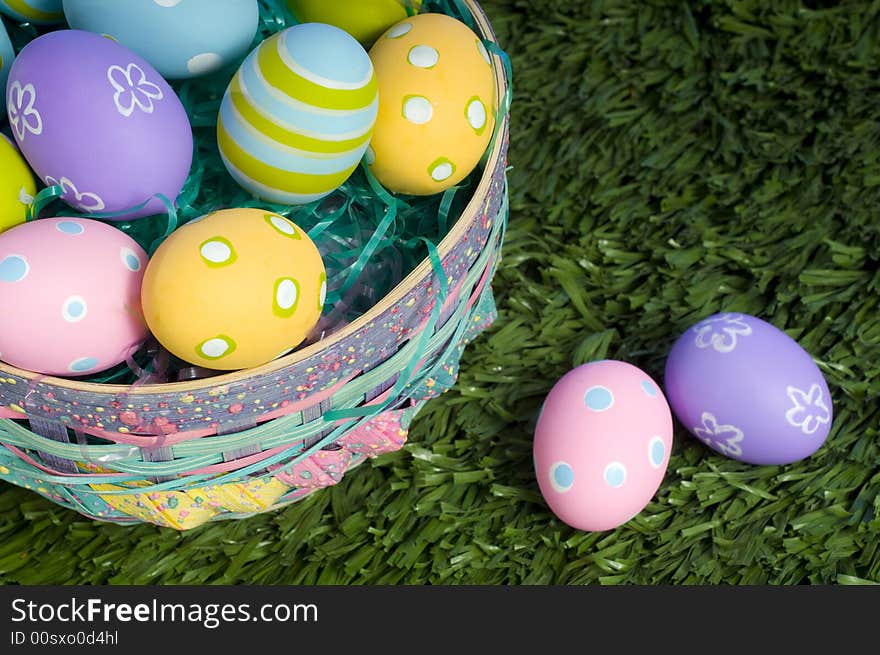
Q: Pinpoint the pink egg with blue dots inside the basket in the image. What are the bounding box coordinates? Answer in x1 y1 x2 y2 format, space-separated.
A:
0 218 147 376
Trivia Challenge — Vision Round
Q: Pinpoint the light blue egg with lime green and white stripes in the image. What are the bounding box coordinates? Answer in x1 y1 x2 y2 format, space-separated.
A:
217 23 378 205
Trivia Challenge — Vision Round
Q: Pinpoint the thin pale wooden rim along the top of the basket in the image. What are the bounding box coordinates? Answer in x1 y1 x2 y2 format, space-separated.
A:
0 0 510 396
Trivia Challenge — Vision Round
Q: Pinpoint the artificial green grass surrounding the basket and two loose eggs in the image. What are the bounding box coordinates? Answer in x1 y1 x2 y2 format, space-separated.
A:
0 0 880 584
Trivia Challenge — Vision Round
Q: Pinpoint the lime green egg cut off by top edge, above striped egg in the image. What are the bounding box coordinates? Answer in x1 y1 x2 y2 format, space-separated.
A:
287 0 422 47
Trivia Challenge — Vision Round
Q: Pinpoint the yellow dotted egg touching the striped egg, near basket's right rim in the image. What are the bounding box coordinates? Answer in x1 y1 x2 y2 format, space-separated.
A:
367 14 496 195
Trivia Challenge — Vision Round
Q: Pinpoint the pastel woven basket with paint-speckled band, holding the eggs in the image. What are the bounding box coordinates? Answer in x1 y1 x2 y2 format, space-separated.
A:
0 0 508 530
